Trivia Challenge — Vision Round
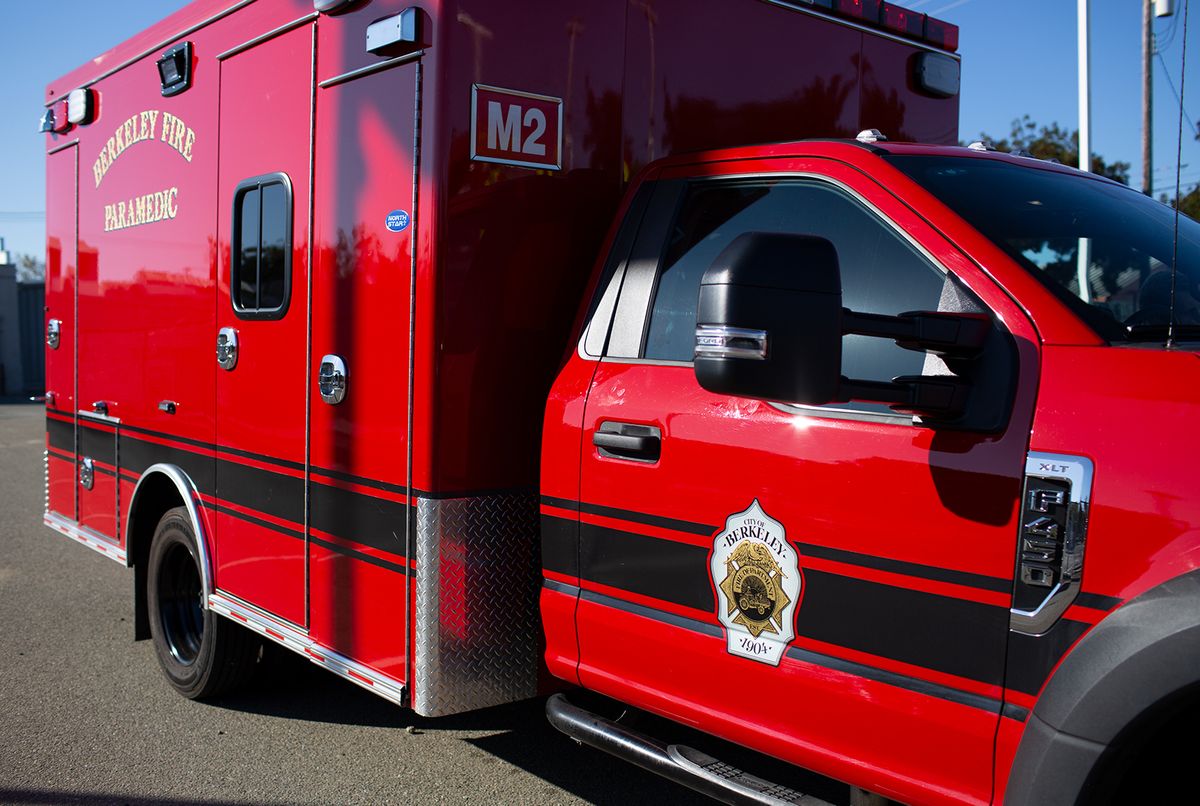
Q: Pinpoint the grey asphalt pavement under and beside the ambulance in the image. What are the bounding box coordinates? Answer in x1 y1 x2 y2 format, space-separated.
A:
0 405 846 806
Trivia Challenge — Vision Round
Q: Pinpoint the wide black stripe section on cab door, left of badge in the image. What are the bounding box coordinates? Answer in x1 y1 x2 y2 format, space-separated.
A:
580 523 715 612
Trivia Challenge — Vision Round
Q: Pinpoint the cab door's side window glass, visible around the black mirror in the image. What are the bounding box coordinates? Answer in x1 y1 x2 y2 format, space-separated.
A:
644 180 947 400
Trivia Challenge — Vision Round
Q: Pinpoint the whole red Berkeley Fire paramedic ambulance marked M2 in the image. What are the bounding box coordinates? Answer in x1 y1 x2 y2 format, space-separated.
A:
42 0 1200 804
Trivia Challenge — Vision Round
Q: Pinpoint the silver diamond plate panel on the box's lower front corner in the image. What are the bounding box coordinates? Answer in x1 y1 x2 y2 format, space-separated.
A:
413 493 541 716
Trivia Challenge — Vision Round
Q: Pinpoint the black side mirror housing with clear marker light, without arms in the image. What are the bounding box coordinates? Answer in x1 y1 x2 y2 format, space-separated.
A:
694 233 842 405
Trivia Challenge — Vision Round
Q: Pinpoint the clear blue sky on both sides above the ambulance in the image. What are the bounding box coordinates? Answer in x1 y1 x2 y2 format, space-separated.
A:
0 0 1200 257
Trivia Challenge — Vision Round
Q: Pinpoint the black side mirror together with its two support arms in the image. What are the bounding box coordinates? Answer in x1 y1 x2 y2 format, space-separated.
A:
694 233 991 420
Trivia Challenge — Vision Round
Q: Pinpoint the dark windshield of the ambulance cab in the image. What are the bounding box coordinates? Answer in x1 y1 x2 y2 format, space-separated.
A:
889 155 1200 342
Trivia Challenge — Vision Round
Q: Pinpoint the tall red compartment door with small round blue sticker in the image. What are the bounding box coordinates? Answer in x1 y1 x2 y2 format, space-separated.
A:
308 62 418 680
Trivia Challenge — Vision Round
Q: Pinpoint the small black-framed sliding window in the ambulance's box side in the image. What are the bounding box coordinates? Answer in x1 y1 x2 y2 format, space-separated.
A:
230 174 292 319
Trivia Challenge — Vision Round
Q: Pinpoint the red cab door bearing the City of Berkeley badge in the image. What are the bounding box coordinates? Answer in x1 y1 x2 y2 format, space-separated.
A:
572 160 1034 802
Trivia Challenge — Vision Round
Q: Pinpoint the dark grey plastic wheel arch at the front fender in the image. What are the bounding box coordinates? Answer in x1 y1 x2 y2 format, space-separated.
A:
1006 570 1200 804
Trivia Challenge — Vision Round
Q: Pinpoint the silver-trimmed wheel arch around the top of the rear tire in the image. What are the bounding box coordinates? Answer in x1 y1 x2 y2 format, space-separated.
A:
125 464 214 640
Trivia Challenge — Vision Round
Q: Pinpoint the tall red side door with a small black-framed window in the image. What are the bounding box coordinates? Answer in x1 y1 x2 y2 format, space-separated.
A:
212 25 313 625
